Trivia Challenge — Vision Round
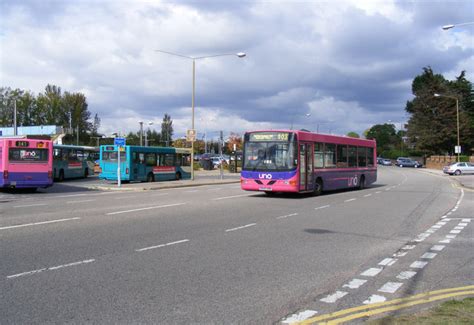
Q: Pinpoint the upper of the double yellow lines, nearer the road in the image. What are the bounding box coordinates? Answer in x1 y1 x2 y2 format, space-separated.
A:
296 285 474 324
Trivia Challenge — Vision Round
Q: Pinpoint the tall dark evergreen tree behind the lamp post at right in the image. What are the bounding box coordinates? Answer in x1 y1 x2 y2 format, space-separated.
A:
405 67 474 154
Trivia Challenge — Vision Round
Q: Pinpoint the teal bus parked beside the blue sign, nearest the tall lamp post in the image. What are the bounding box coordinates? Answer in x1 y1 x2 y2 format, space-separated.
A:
99 145 191 182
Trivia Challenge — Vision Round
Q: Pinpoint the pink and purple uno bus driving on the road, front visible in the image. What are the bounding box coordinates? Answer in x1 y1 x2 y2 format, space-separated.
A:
241 130 377 195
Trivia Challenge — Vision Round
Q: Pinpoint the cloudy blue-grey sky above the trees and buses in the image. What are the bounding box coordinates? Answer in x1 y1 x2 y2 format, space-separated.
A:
0 0 474 139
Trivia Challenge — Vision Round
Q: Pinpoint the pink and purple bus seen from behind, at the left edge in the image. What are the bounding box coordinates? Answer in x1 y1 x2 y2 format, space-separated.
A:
0 138 53 189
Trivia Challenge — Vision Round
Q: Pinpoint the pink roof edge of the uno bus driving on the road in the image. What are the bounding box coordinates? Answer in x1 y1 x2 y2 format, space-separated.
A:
245 129 376 147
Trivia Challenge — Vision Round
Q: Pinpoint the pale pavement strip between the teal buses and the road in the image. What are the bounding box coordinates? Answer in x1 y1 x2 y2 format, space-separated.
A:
88 169 240 191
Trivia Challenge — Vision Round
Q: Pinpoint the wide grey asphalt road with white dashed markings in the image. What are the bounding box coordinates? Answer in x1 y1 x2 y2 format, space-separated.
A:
0 167 474 324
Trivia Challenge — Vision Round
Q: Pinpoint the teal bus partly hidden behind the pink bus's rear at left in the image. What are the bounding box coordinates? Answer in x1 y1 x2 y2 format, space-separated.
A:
53 144 99 182
